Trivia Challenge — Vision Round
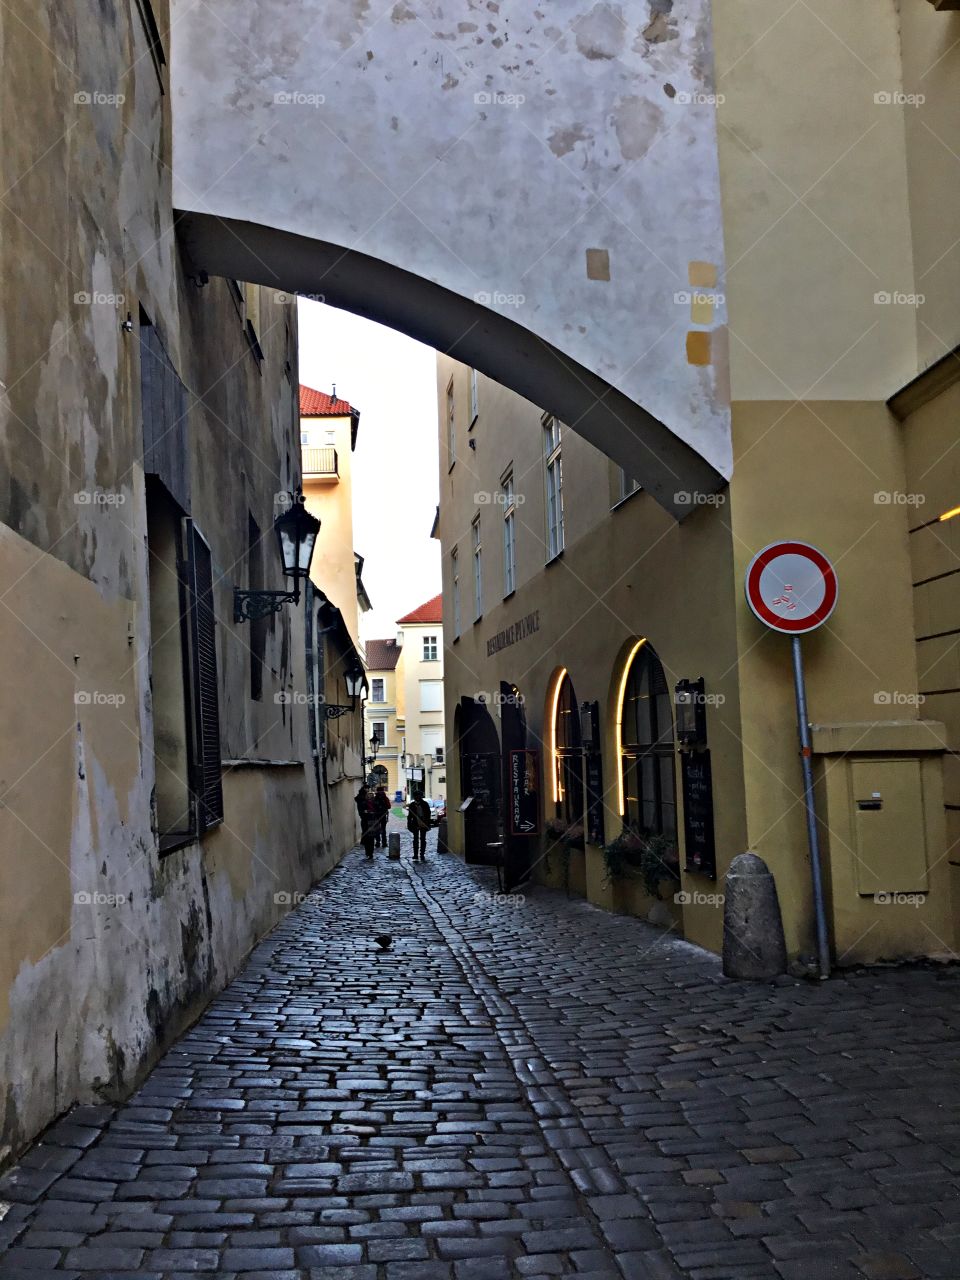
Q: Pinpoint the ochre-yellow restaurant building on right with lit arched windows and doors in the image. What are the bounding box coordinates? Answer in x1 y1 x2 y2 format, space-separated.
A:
438 304 960 968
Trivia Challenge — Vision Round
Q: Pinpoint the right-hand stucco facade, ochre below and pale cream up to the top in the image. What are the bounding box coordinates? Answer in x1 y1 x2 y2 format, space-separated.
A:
438 0 960 963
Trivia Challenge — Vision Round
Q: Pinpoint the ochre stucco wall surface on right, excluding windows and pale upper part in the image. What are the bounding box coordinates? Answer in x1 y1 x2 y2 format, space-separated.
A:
438 345 960 964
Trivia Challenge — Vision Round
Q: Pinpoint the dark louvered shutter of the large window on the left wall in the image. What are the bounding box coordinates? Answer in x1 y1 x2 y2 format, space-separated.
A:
187 520 223 835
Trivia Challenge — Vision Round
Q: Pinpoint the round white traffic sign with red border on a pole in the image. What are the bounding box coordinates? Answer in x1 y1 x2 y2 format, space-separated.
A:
744 543 837 635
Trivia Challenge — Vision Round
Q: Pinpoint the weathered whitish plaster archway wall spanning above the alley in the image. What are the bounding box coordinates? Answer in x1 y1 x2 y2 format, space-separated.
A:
172 0 731 506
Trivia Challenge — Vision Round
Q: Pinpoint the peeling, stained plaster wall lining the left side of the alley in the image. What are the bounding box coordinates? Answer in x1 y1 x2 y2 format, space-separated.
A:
0 0 353 1162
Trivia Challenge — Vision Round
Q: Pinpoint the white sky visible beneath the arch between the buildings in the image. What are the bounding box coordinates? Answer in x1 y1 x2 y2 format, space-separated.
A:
298 298 440 641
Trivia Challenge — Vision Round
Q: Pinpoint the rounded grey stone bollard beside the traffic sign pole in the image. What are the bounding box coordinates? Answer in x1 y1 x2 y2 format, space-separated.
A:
723 854 787 982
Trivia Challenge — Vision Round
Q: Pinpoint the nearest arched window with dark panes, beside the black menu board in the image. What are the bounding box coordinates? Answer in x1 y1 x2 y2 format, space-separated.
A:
620 641 677 837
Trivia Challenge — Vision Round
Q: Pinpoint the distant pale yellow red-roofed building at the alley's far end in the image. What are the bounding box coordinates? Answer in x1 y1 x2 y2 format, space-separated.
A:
366 595 447 799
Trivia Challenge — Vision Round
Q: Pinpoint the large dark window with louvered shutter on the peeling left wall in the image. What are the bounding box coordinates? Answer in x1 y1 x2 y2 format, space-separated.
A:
147 477 223 852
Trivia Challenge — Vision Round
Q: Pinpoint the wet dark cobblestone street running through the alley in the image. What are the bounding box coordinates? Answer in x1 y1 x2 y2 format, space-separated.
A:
0 836 960 1280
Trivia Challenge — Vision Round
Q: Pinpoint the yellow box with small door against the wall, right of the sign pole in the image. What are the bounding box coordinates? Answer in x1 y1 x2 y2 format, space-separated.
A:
813 721 954 965
